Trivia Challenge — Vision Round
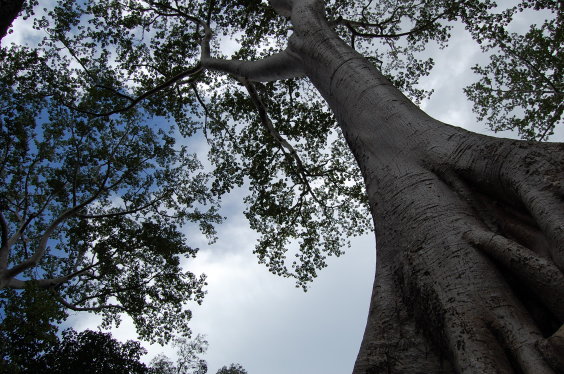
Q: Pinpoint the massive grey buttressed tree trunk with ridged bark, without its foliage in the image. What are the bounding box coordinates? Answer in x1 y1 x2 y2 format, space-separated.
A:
286 0 564 374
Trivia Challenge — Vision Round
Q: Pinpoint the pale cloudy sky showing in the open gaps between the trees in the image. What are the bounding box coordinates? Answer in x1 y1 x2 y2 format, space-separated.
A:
6 2 564 374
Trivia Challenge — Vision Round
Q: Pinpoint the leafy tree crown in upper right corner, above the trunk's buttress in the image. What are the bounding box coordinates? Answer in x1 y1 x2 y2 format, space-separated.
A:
465 1 564 140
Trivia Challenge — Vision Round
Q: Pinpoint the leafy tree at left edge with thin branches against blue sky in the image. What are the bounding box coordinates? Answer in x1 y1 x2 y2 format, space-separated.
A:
0 35 220 342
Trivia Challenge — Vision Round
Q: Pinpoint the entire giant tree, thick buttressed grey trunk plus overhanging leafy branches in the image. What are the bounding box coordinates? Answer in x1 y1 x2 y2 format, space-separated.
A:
2 0 564 374
